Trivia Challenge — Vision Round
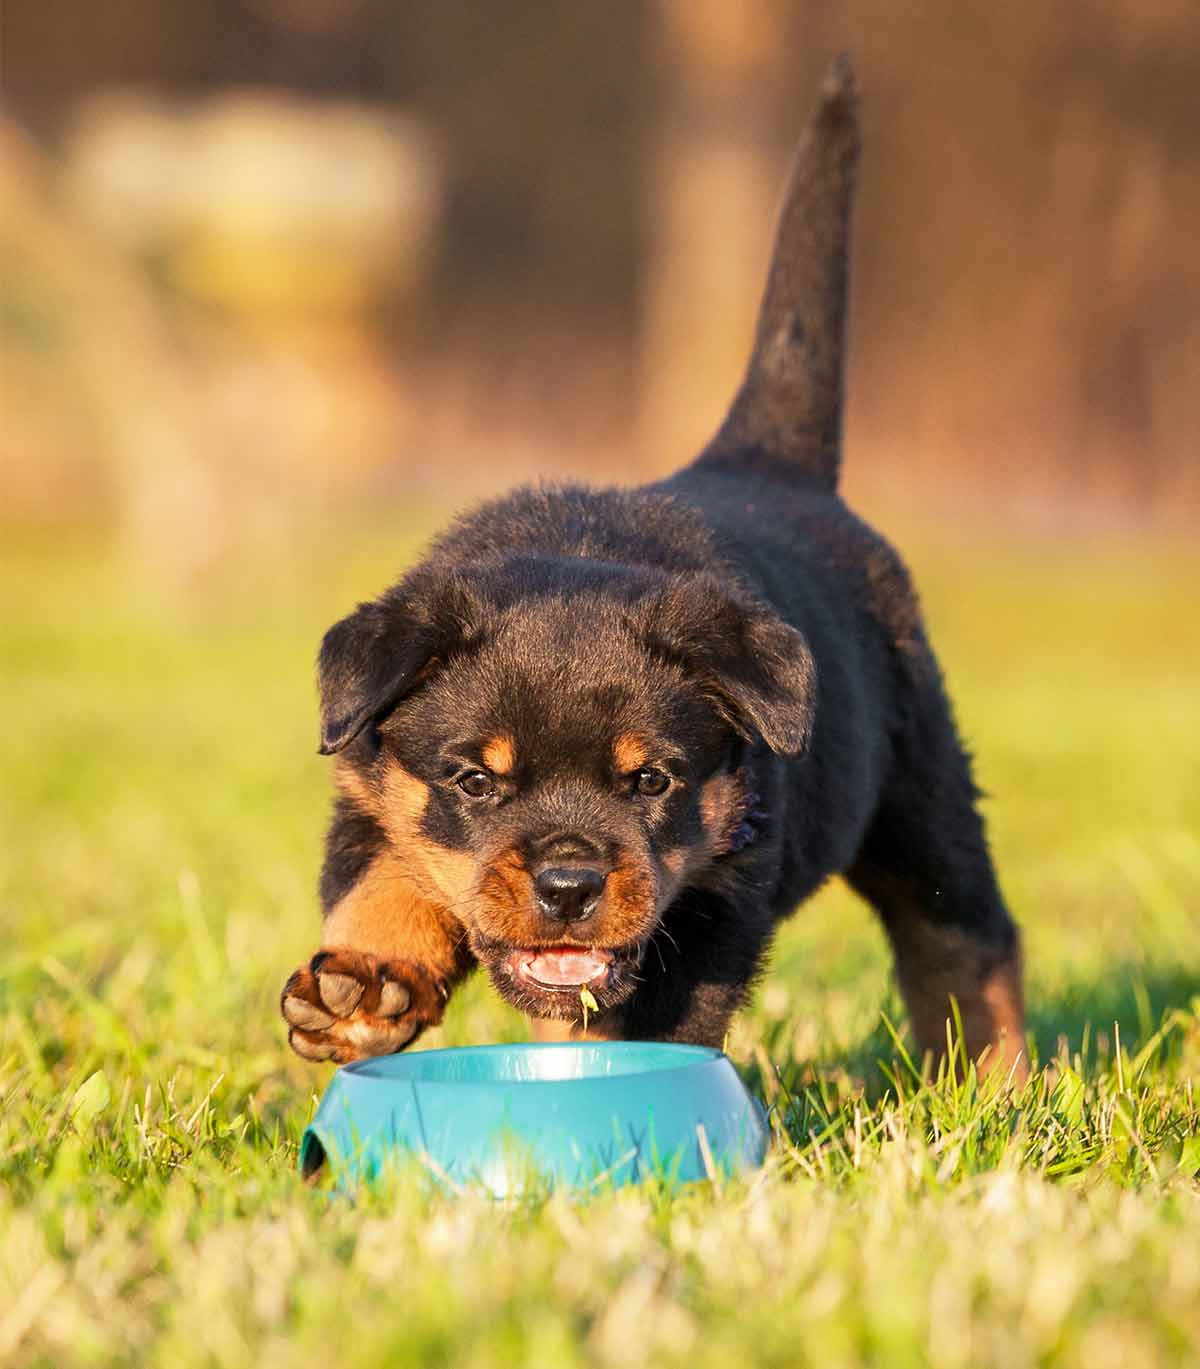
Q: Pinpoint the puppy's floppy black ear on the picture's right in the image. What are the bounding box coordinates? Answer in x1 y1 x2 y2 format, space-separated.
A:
646 575 817 756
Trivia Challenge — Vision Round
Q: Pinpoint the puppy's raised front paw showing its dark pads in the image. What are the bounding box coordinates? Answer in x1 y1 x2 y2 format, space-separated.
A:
279 947 446 1065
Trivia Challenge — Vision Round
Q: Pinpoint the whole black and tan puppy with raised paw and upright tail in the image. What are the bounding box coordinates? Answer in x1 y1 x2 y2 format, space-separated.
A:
282 64 1023 1073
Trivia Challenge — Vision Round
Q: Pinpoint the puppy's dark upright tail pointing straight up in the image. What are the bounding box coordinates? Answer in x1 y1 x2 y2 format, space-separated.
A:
698 53 861 489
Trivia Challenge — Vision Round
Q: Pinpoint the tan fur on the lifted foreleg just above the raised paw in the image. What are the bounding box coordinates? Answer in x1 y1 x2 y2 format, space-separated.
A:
323 852 464 980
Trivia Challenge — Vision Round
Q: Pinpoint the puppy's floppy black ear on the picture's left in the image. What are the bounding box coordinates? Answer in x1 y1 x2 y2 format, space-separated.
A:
317 578 478 756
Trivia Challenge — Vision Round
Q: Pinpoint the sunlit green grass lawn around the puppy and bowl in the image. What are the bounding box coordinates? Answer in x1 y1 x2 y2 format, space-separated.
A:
0 517 1200 1369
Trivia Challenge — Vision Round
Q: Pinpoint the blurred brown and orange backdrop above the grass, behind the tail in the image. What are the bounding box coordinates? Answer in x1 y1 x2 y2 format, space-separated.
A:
7 0 1200 582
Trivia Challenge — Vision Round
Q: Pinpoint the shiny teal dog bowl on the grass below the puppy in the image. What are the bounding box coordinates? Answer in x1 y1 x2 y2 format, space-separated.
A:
300 1040 766 1197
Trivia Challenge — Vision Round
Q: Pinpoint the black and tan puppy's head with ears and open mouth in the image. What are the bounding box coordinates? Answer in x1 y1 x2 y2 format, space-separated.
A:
320 557 814 1017
